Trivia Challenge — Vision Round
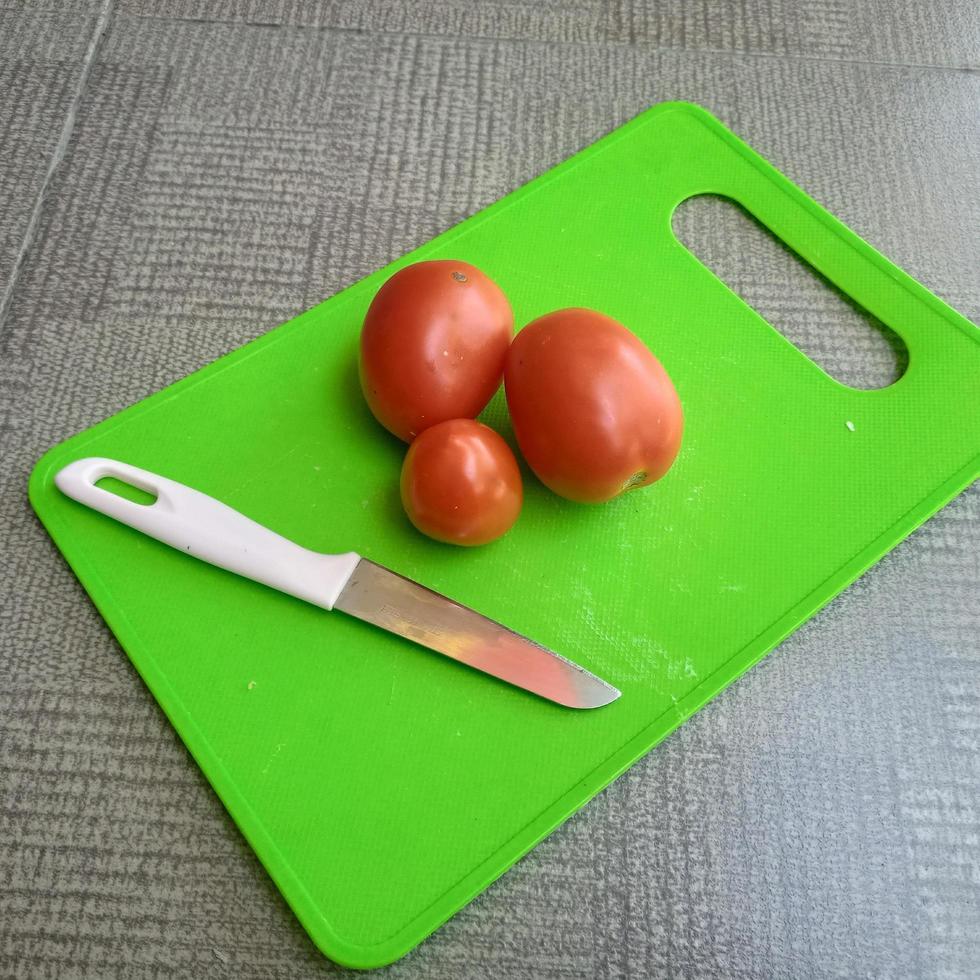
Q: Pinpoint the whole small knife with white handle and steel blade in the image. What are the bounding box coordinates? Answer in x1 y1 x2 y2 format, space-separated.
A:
54 457 620 708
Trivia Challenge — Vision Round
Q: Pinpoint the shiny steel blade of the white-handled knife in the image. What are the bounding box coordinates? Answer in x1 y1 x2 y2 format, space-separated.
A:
334 558 620 708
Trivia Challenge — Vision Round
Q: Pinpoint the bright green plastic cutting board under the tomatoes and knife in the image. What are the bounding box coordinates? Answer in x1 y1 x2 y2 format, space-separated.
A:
30 103 980 967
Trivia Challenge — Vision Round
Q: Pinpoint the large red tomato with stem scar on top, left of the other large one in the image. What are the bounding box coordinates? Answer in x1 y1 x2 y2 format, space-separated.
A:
360 259 514 442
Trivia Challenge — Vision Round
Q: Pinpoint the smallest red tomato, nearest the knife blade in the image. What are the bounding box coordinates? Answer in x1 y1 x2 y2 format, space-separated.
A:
401 419 524 545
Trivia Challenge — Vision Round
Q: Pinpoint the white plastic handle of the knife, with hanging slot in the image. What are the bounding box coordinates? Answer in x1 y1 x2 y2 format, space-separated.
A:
54 457 360 609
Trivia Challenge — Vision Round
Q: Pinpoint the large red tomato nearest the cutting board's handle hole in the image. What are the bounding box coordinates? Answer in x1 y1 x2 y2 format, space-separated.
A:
504 309 684 503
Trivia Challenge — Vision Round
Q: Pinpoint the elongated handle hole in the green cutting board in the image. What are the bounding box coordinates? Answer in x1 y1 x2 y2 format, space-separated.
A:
672 194 909 389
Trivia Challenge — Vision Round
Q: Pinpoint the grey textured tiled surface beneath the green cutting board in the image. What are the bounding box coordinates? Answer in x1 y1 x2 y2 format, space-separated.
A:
0 0 980 978
